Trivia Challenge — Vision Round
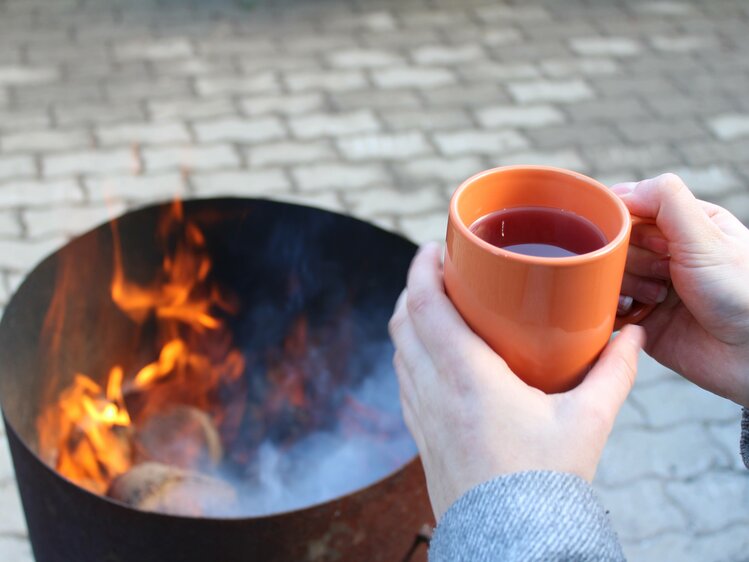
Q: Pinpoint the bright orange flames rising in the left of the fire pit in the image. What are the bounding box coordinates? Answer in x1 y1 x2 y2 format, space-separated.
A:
37 201 244 493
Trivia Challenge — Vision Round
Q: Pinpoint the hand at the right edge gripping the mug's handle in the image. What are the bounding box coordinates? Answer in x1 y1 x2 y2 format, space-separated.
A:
612 174 749 407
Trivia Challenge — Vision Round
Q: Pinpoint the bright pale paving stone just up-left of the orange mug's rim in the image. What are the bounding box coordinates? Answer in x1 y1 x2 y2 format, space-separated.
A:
337 131 433 160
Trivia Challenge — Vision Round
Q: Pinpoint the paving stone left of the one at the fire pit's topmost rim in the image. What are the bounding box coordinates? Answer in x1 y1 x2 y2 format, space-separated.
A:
85 173 187 204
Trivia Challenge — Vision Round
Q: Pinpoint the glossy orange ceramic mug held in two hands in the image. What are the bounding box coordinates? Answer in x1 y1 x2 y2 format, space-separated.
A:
444 166 653 394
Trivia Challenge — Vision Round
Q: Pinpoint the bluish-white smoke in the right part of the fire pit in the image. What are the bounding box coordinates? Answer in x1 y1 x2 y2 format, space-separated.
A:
223 345 416 516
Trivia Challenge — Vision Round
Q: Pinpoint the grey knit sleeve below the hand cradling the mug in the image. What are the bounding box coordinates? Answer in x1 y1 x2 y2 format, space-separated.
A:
429 471 625 562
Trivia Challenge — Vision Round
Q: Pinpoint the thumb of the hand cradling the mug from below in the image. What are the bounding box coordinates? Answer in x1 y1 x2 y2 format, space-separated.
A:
573 324 645 424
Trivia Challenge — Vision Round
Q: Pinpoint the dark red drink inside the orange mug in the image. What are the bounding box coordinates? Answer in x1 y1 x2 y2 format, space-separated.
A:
471 207 608 258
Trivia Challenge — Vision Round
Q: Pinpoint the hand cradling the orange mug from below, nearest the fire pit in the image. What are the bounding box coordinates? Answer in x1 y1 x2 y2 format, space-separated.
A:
390 245 644 519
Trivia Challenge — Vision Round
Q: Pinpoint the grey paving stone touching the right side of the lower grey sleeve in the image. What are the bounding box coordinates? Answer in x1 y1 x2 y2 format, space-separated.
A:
596 479 687 541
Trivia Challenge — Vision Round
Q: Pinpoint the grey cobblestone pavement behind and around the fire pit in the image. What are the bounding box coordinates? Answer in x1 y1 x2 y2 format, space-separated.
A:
0 0 749 562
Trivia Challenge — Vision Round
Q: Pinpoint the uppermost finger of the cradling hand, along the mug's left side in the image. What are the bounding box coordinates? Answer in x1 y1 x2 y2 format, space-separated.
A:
407 244 504 376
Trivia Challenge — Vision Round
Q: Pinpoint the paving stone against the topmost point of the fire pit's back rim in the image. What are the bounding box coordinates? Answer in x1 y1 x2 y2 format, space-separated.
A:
191 169 291 197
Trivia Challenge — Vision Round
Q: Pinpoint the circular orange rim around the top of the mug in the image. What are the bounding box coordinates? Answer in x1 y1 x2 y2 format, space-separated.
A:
449 164 632 267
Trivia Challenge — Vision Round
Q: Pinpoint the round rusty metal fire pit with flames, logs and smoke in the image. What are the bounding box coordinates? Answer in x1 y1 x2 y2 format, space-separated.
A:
0 199 431 562
